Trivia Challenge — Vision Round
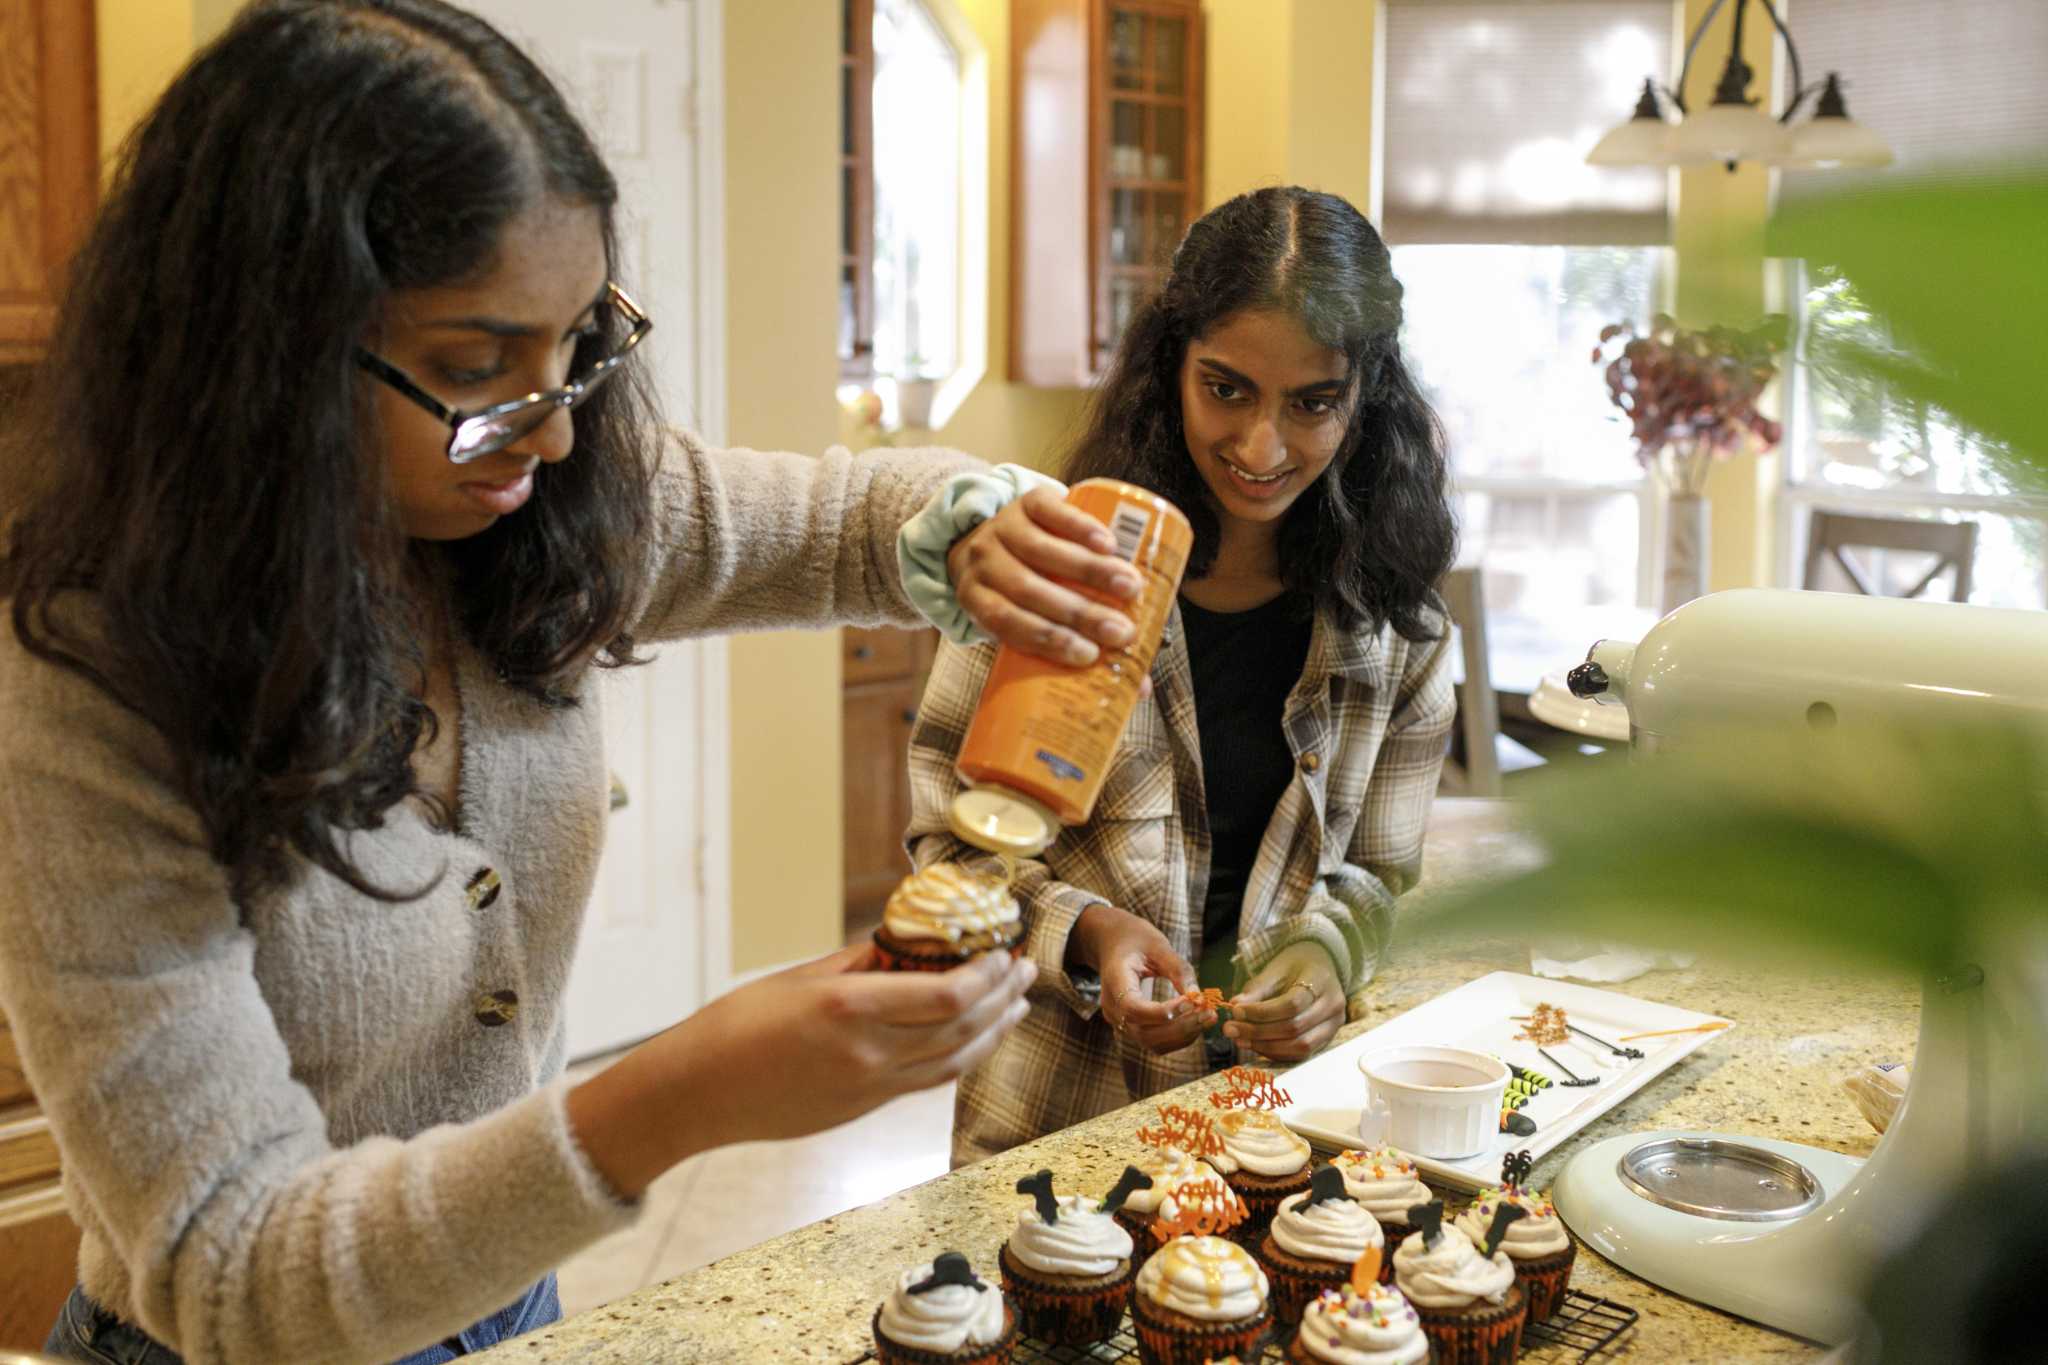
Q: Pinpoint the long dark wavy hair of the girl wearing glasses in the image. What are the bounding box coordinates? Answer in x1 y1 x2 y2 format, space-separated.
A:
0 0 655 898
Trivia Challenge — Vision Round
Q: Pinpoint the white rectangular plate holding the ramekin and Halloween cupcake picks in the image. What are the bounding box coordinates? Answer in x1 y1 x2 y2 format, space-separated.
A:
1280 972 1726 1191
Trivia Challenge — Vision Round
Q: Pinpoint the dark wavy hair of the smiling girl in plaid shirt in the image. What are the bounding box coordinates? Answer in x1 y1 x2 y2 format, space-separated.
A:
1063 186 1458 641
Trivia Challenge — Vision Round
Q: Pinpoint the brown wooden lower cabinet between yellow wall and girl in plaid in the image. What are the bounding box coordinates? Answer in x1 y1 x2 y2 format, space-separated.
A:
840 628 938 931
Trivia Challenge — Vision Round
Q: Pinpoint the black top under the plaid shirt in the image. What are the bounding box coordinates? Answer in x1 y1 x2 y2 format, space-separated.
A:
1180 591 1315 990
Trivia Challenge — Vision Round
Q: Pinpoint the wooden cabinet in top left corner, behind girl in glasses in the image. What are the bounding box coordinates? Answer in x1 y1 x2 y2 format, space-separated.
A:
0 0 100 366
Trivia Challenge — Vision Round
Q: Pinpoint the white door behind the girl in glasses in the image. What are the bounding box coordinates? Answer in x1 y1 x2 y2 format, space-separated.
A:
465 0 731 1058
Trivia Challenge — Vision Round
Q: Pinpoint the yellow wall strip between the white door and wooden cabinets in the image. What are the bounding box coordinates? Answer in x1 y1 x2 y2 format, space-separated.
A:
725 0 842 972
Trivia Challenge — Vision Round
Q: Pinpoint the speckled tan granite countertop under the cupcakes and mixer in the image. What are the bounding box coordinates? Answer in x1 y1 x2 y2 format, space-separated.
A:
479 800 1919 1365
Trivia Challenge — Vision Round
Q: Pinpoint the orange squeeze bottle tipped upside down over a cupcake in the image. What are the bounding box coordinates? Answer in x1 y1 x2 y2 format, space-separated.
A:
948 479 1194 857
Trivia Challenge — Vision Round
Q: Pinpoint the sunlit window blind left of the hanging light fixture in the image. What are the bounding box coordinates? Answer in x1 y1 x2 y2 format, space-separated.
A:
1380 0 1671 246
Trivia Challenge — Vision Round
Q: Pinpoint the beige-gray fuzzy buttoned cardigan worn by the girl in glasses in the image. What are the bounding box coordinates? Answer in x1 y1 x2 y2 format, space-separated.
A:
0 438 969 1365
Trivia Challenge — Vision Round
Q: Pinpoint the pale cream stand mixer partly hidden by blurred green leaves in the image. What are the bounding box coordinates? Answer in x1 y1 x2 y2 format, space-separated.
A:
1552 589 2048 1342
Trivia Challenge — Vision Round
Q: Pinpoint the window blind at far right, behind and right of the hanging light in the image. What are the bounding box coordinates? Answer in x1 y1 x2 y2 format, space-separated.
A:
1780 0 2048 199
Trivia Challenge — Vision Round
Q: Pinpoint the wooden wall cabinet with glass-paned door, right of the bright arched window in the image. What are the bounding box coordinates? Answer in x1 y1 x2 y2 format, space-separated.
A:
1010 0 1202 387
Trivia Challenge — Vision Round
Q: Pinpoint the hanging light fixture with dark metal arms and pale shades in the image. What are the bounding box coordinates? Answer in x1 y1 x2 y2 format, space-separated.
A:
1585 0 1892 170
